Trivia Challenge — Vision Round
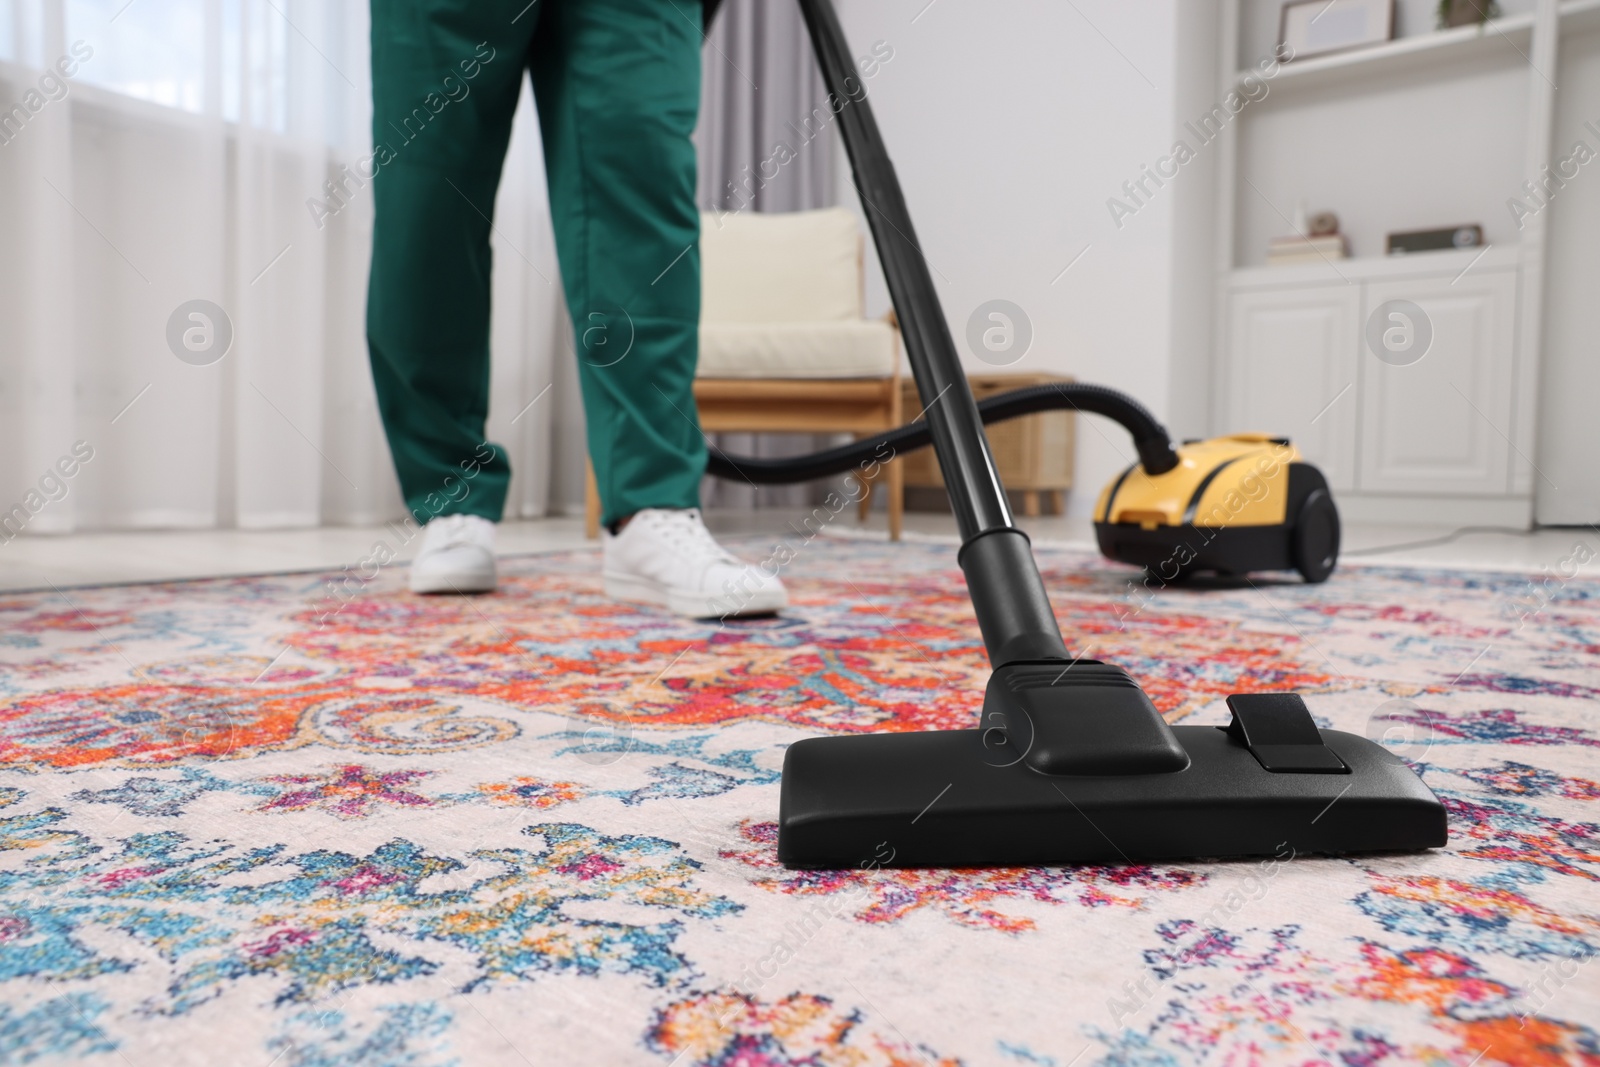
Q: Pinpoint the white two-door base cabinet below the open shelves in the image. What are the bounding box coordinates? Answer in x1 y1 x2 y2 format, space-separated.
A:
1216 259 1531 525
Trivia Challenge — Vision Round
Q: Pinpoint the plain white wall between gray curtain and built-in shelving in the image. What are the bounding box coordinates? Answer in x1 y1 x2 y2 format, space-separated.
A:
838 0 1211 514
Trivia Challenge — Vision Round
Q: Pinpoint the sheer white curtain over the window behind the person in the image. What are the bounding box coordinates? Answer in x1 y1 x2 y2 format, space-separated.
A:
0 0 570 536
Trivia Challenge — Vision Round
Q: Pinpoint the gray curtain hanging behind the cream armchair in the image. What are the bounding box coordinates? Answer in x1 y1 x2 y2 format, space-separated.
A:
694 0 835 507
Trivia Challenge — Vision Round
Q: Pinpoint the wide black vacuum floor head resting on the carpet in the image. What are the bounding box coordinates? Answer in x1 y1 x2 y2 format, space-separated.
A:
778 671 1446 867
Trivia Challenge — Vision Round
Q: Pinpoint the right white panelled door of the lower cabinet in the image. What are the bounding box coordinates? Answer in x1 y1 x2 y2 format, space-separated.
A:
1358 272 1517 494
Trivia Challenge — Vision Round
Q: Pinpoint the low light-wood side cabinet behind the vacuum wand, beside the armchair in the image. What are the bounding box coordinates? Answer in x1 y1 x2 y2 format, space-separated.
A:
901 374 1075 515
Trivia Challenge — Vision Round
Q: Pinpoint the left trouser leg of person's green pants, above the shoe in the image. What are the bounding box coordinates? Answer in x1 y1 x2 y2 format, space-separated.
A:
366 0 542 523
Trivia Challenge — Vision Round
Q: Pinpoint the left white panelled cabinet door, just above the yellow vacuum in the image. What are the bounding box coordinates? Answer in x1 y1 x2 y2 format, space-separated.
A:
1222 285 1362 491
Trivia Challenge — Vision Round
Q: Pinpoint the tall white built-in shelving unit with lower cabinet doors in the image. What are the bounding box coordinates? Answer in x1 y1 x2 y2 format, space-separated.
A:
1211 0 1574 526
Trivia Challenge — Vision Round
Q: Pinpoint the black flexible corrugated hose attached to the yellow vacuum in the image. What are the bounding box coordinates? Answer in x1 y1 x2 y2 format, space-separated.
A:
706 382 1178 485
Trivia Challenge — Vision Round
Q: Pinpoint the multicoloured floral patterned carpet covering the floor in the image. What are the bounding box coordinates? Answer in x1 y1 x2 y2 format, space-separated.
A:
0 537 1600 1067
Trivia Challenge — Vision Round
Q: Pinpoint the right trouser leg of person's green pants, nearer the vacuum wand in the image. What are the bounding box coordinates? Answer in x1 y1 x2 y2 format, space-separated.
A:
530 0 706 523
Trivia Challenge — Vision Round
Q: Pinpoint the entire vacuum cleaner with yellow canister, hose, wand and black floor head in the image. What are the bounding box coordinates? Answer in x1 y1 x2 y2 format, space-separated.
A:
755 0 1445 867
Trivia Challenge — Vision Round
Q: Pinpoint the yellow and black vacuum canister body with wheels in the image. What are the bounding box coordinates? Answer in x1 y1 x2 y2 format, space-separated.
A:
1094 434 1339 582
